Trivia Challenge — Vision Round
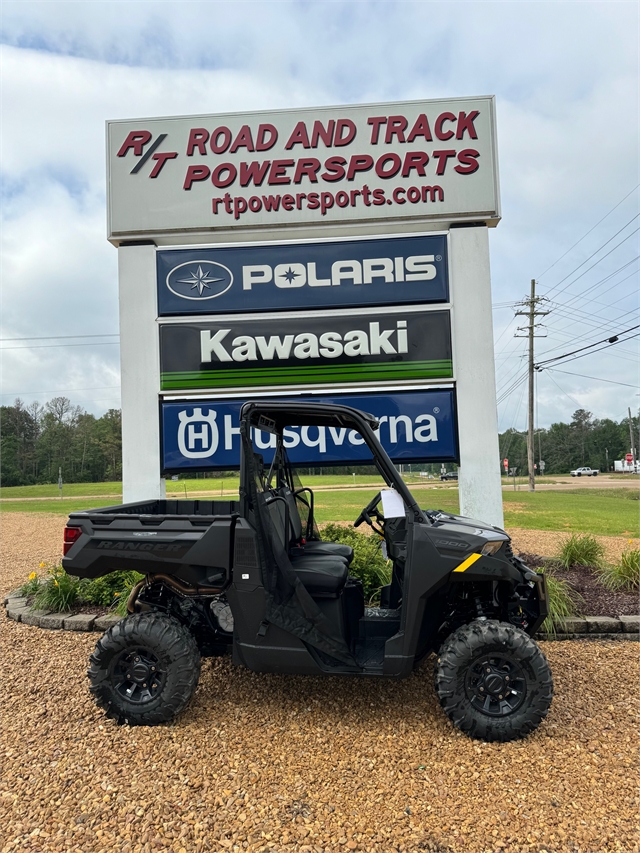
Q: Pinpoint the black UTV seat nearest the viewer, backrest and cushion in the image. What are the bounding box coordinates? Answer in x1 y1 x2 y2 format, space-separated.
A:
265 494 349 598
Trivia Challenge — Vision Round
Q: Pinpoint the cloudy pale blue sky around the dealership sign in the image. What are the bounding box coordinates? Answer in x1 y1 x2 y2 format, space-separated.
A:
0 0 640 431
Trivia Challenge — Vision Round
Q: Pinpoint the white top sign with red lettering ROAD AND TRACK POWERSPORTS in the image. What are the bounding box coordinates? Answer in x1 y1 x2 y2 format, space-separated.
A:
107 97 500 242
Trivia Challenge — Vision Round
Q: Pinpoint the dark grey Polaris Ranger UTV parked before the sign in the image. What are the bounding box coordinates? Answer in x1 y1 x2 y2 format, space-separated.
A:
62 401 553 741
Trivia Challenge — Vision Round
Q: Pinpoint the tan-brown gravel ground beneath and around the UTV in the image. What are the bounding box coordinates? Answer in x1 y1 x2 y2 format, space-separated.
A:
0 515 640 853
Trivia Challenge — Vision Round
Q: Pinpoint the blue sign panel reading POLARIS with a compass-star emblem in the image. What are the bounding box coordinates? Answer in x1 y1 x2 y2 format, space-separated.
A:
156 235 449 316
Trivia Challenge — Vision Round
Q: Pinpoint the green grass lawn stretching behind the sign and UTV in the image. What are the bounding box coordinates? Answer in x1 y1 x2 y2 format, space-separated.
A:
1 474 640 537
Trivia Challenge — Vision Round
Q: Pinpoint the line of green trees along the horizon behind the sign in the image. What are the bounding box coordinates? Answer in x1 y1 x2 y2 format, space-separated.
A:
0 397 640 486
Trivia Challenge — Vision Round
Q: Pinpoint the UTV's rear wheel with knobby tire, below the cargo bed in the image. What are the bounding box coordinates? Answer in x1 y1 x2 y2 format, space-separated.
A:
87 613 200 726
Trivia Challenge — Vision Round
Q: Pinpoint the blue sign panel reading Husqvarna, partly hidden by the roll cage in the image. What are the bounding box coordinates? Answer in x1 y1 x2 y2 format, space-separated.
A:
162 389 458 473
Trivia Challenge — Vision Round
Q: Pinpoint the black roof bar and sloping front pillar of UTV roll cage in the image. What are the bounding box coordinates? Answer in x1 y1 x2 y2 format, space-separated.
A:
240 402 429 523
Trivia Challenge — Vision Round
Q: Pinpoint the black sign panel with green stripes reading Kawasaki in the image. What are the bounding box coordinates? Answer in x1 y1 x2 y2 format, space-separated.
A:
160 308 453 391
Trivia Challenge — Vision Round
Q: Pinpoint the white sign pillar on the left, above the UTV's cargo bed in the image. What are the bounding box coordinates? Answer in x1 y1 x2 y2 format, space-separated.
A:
118 244 166 503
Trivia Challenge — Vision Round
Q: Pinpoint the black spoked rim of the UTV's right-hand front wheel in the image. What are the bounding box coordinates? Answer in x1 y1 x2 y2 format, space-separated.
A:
465 652 527 717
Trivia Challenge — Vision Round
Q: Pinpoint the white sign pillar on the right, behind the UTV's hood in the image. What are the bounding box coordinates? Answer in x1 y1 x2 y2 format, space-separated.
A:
449 226 504 527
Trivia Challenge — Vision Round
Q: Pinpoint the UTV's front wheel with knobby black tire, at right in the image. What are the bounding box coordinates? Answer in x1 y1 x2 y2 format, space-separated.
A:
435 619 553 741
